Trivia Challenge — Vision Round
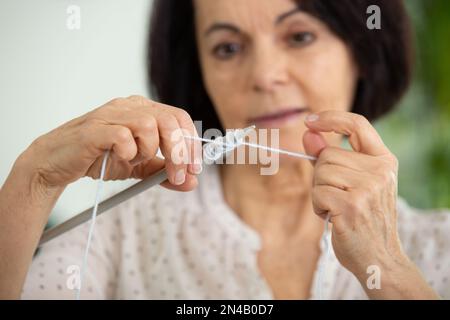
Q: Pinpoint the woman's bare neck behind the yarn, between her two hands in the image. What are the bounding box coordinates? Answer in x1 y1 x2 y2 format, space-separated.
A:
220 161 323 242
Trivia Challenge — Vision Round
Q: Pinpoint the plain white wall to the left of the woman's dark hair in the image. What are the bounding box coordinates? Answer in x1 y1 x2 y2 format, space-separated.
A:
0 0 151 223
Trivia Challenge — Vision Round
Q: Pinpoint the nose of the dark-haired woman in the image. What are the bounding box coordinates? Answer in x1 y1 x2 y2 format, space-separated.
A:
251 43 289 92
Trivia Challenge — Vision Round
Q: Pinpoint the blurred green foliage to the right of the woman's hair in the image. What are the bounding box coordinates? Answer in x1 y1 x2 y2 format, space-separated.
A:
376 0 450 208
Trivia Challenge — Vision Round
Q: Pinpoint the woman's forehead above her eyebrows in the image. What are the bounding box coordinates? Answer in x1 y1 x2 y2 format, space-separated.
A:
194 0 297 28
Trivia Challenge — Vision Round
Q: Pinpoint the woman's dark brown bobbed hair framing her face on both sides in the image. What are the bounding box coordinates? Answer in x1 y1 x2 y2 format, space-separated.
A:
148 0 413 128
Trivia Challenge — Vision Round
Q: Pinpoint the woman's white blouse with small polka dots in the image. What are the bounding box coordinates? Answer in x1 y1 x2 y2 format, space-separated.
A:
22 166 450 299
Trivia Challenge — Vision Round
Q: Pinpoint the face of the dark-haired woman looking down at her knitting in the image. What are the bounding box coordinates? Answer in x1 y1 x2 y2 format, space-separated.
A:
194 0 358 151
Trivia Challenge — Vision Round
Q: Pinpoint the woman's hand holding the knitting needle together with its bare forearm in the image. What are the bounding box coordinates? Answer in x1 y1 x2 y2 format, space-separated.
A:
0 96 202 299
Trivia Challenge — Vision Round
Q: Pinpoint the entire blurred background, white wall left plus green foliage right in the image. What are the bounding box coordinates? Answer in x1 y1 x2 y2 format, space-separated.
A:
0 0 450 224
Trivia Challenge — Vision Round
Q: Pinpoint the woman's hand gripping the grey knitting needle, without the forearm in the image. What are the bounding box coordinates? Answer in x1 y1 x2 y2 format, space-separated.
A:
21 96 202 191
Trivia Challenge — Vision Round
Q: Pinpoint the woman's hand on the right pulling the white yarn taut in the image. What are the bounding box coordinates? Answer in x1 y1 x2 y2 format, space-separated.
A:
303 111 438 300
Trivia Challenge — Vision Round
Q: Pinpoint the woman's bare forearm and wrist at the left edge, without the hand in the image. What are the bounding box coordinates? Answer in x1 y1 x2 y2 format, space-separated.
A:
0 151 64 299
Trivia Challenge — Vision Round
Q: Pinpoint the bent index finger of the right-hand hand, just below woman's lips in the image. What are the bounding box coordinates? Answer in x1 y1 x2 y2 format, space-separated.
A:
305 110 389 156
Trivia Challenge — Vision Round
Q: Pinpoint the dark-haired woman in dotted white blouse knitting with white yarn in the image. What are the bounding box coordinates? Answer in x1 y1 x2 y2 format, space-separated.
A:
0 0 450 299
